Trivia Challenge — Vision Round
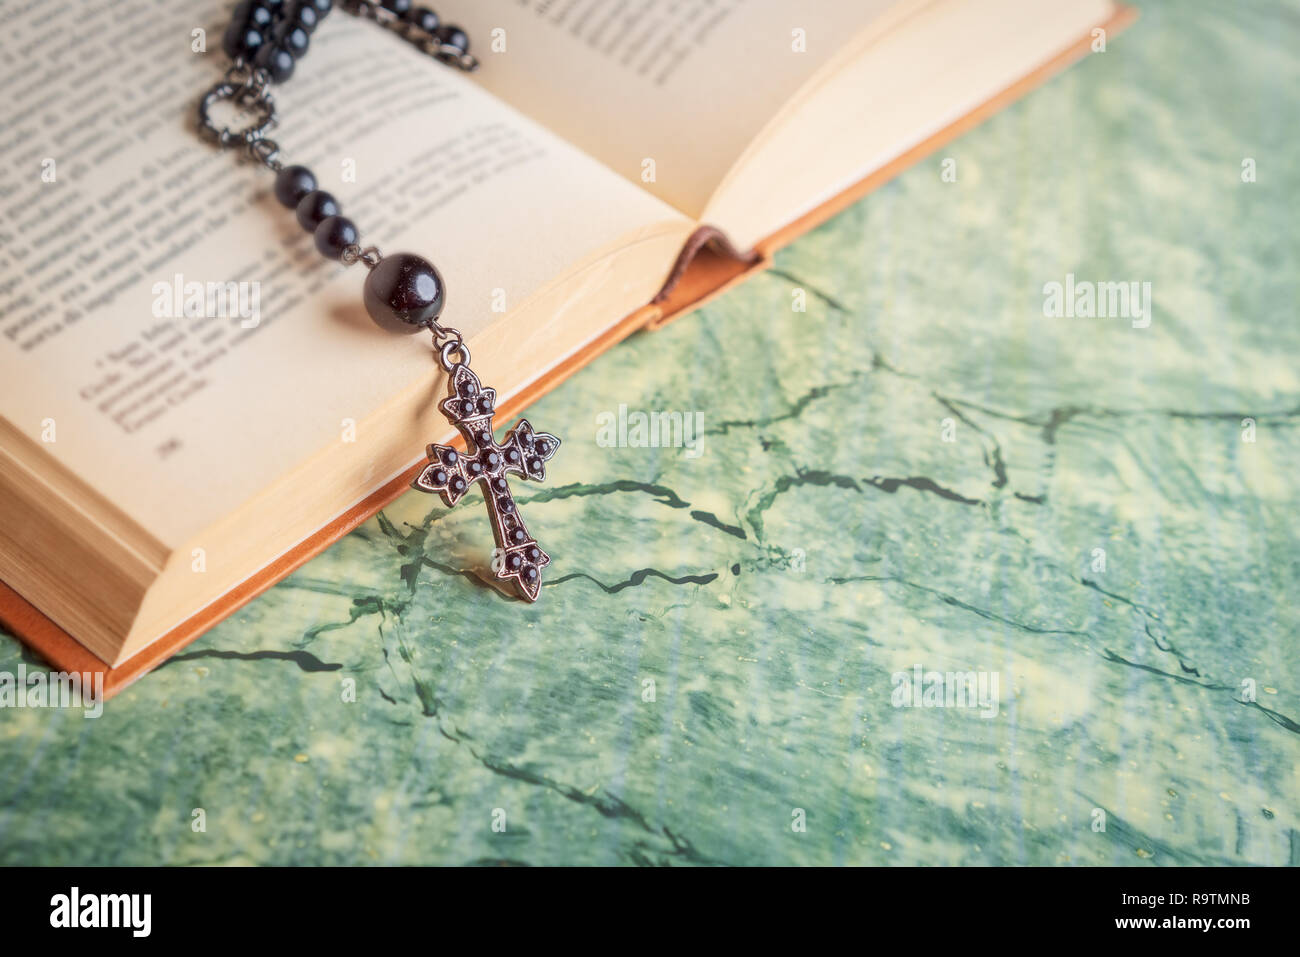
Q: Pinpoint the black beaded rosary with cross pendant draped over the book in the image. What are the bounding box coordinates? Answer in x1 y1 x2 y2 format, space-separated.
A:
199 0 559 602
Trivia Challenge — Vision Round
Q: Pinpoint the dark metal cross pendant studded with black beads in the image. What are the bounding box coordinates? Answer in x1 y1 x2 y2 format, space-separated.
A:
412 363 560 602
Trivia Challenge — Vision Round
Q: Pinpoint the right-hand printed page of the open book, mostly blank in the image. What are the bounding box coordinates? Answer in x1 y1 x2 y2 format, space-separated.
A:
438 0 924 218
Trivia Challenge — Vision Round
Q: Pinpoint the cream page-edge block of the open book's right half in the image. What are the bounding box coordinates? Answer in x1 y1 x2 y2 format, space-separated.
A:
703 0 1114 248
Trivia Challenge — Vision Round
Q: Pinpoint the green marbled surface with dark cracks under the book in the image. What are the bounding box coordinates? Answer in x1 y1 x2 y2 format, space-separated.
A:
0 0 1300 865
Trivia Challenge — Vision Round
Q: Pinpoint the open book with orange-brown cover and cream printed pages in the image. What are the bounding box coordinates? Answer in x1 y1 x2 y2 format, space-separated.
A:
0 0 1123 675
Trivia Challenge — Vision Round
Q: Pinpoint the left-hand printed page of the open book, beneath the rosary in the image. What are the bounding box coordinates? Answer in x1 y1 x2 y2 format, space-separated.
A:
0 0 689 545
